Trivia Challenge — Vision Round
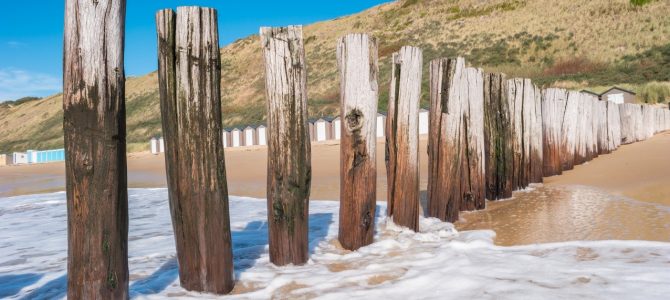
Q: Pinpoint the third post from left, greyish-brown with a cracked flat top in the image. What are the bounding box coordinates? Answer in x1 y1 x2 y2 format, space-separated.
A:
260 26 312 266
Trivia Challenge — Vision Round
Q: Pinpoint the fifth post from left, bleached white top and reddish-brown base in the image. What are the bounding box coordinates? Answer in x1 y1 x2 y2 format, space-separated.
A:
386 46 423 231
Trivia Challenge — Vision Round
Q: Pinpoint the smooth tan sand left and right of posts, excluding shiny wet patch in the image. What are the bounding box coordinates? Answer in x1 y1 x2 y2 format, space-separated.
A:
0 132 670 206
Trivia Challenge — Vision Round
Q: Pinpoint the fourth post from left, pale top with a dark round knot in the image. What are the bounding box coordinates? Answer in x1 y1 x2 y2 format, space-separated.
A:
337 34 379 250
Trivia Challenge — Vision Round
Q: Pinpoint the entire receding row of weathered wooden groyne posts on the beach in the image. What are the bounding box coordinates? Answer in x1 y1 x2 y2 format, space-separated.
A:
63 0 670 299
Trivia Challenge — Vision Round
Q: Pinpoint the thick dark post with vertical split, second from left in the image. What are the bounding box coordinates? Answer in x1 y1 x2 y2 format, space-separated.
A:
156 6 234 294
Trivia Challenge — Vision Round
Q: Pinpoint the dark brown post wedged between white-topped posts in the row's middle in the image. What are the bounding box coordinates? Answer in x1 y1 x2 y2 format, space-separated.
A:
484 74 513 200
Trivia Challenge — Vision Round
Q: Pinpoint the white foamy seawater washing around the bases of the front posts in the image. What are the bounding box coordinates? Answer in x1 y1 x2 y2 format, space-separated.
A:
0 189 670 299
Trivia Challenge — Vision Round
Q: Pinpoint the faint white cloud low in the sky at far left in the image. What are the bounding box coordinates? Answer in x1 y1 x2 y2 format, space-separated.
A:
0 68 63 102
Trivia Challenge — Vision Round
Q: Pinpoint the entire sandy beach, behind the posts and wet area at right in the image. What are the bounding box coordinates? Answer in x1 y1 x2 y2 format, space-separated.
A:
0 132 670 245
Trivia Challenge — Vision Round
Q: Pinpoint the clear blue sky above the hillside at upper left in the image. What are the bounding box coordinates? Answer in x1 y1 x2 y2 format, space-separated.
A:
0 0 390 101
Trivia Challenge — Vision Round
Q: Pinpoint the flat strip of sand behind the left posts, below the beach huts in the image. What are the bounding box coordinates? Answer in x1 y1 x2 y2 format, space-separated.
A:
0 138 428 201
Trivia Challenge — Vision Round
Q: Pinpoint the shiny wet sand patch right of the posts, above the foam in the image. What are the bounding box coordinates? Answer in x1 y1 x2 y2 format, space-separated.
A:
455 185 670 246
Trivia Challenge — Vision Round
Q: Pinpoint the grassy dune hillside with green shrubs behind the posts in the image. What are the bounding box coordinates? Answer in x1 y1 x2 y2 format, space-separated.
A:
0 0 670 153
